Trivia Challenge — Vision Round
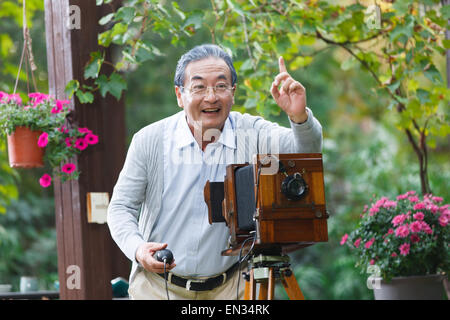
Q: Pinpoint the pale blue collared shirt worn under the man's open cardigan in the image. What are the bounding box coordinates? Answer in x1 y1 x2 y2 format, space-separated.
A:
149 112 237 277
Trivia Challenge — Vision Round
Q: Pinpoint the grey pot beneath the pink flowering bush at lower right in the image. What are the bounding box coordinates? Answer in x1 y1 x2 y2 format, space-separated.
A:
373 274 445 300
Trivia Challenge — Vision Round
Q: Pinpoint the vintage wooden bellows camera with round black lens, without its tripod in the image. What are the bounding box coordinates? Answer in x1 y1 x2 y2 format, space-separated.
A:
204 153 328 255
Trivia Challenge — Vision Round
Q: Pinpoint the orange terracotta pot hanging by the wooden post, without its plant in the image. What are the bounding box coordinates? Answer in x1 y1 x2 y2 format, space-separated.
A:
8 127 44 168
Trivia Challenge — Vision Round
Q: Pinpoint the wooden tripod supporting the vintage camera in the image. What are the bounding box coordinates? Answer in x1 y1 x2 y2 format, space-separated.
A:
244 255 305 300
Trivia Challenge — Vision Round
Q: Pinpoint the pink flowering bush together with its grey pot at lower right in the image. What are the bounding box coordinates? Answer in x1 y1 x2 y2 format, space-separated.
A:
341 191 450 300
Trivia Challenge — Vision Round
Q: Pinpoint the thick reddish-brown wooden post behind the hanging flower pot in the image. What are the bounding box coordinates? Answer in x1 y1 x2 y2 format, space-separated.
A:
45 0 130 299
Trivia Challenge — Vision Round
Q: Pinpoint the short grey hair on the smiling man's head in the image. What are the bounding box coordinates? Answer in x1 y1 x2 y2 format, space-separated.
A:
174 44 237 87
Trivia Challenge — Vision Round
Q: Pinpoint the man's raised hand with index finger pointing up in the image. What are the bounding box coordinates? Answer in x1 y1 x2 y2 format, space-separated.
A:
270 57 308 123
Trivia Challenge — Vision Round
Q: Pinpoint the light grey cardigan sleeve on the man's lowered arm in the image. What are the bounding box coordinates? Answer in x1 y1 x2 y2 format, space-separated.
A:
107 133 148 262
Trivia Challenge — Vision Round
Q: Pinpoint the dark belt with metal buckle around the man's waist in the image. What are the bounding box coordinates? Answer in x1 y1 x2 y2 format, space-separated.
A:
158 263 243 291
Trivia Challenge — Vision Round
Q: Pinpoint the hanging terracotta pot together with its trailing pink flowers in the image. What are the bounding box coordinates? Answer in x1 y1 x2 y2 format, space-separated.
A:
0 92 98 188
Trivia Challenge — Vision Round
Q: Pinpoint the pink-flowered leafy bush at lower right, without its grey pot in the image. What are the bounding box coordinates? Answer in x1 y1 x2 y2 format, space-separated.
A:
340 191 450 281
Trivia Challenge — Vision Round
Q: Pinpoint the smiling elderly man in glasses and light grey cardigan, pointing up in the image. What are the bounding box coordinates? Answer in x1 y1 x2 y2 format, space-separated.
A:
108 45 322 299
